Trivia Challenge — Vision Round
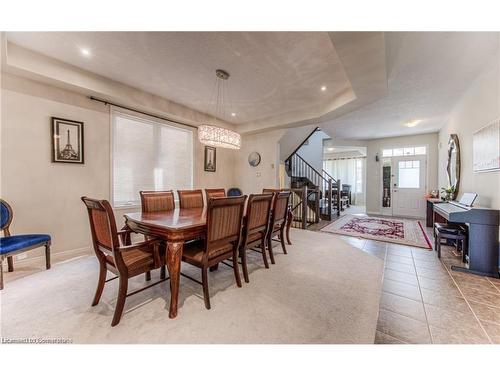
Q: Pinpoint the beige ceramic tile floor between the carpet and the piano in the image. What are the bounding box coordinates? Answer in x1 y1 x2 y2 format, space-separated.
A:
341 236 500 344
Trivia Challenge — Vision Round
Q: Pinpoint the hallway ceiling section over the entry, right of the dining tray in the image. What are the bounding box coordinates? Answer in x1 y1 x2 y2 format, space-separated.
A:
319 32 500 139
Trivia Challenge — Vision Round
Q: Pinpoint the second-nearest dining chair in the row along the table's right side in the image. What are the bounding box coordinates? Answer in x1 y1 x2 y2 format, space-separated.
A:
240 194 273 283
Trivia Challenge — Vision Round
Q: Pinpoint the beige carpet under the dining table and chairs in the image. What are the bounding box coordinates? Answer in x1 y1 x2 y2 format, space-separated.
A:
1 230 383 344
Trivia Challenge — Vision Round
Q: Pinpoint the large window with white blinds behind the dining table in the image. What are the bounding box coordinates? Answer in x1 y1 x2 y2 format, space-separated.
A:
112 112 193 207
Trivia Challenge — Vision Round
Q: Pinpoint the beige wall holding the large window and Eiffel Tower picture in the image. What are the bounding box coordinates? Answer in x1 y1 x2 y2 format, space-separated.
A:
1 75 236 257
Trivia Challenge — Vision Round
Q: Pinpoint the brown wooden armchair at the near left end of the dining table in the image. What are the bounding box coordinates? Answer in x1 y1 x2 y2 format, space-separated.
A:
82 197 167 327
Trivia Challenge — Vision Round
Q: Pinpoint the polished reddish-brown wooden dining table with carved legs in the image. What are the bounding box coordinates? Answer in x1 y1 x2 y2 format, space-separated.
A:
124 206 293 319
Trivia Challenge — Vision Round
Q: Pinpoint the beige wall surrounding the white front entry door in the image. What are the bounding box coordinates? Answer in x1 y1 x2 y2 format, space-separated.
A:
366 133 438 214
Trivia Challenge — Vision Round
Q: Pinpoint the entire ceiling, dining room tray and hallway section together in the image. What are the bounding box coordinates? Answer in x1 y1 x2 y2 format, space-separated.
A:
3 32 492 140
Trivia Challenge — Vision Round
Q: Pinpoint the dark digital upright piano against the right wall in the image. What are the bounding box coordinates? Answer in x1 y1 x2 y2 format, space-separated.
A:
434 201 500 278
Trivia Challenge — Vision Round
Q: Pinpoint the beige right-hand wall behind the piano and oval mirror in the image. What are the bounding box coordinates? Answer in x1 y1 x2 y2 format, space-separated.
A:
439 56 500 209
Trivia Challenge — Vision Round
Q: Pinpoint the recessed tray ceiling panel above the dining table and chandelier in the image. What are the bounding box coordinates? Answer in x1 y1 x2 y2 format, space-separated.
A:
7 32 354 125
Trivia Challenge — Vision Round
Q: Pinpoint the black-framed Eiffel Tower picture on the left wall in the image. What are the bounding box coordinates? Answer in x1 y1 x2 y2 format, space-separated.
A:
51 117 84 164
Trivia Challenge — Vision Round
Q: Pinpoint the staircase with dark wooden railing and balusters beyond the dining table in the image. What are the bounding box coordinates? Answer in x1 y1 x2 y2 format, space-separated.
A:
285 128 341 229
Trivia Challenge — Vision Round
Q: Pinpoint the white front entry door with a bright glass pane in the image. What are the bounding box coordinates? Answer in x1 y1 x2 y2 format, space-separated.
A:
392 155 427 217
